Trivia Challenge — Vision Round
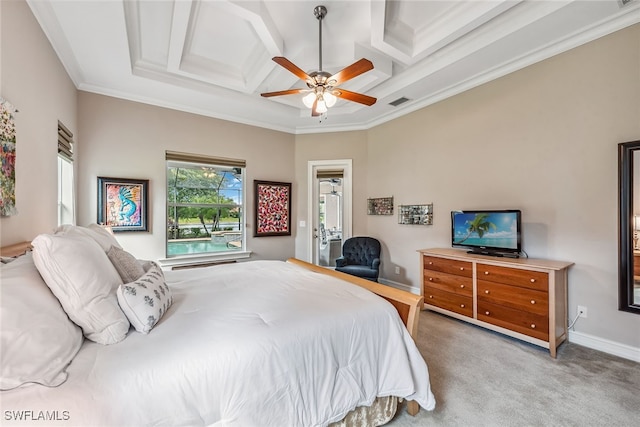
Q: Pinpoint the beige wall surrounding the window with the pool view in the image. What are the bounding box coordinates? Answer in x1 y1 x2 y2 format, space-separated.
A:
77 92 298 259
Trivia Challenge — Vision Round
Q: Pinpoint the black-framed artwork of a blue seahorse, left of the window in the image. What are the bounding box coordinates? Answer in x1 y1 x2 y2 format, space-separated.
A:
98 176 149 232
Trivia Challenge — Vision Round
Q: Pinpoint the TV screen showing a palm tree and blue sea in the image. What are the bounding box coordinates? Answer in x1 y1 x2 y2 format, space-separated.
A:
452 212 518 250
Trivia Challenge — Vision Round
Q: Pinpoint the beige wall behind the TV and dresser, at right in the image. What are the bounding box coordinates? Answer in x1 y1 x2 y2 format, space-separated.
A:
367 25 640 348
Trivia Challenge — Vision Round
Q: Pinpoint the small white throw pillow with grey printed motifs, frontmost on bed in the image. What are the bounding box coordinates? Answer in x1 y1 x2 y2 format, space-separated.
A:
117 263 173 334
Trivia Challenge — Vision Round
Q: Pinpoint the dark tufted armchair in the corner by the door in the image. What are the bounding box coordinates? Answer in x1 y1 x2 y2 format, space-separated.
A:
336 237 381 282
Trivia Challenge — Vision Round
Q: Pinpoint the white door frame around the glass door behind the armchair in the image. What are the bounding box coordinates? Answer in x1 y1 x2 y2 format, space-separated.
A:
307 159 353 264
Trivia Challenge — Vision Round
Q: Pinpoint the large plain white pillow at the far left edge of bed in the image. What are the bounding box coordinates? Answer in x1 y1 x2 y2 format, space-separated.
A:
0 253 82 390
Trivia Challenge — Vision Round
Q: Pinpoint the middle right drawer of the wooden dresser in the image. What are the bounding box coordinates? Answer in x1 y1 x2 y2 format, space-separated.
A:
478 280 549 316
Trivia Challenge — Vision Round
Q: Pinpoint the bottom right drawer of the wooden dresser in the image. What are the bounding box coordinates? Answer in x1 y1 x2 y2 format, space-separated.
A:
478 299 549 341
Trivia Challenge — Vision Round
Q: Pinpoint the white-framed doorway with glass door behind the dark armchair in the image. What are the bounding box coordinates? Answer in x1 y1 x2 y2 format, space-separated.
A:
308 159 352 267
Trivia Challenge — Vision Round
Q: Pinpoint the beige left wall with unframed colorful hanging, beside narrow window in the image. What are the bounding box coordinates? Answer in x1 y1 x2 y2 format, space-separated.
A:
0 1 77 245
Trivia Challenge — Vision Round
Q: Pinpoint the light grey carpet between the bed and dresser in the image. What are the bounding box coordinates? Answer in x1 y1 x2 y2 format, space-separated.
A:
387 311 640 427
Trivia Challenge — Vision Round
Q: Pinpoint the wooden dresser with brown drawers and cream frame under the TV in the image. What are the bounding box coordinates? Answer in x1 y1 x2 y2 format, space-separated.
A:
419 249 573 358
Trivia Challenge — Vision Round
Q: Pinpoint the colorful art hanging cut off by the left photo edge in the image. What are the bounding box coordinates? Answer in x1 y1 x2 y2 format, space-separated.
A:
0 98 18 216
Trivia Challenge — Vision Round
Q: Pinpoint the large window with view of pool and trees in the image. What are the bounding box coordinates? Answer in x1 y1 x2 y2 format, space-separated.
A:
166 151 246 257
